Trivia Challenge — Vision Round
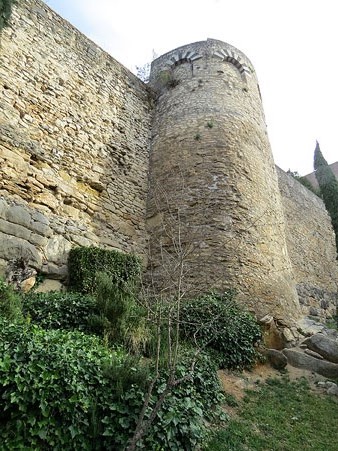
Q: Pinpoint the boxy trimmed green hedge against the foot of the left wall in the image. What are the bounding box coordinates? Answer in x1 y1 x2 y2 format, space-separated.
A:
68 247 140 294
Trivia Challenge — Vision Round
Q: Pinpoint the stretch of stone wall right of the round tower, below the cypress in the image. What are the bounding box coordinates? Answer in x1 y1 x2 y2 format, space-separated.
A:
277 168 338 317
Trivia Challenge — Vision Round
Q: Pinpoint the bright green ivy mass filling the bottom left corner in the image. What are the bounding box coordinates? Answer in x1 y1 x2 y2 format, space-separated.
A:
0 320 142 450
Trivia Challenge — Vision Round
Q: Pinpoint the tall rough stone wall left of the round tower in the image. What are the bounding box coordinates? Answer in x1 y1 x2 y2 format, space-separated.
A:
0 0 151 277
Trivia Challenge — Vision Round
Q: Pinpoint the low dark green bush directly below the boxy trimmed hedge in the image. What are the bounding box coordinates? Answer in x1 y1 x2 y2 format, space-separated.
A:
23 291 99 333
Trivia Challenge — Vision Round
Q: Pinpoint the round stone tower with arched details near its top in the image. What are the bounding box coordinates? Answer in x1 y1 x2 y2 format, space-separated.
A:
148 39 299 322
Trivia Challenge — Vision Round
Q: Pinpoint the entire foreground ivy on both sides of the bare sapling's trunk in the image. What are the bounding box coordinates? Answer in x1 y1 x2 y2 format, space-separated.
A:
0 319 226 450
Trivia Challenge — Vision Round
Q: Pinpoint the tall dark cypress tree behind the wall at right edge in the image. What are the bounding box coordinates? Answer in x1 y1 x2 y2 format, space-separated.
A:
314 142 338 253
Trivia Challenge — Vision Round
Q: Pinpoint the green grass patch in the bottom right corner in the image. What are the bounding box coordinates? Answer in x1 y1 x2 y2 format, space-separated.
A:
204 378 338 451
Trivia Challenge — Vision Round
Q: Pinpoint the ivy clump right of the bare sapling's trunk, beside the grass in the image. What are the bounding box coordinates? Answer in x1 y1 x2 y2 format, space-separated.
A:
136 351 225 451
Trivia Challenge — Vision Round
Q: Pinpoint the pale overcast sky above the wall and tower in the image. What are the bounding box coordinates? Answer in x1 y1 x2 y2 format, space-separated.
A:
46 0 338 175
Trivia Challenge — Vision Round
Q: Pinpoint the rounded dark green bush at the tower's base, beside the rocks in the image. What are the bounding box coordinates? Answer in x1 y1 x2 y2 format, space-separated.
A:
180 291 261 368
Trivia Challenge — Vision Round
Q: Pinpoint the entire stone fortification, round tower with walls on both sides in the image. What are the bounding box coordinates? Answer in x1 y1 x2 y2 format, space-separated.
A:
0 0 337 321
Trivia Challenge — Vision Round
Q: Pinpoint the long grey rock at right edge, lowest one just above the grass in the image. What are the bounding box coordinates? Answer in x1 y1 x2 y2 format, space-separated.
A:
283 349 338 378
